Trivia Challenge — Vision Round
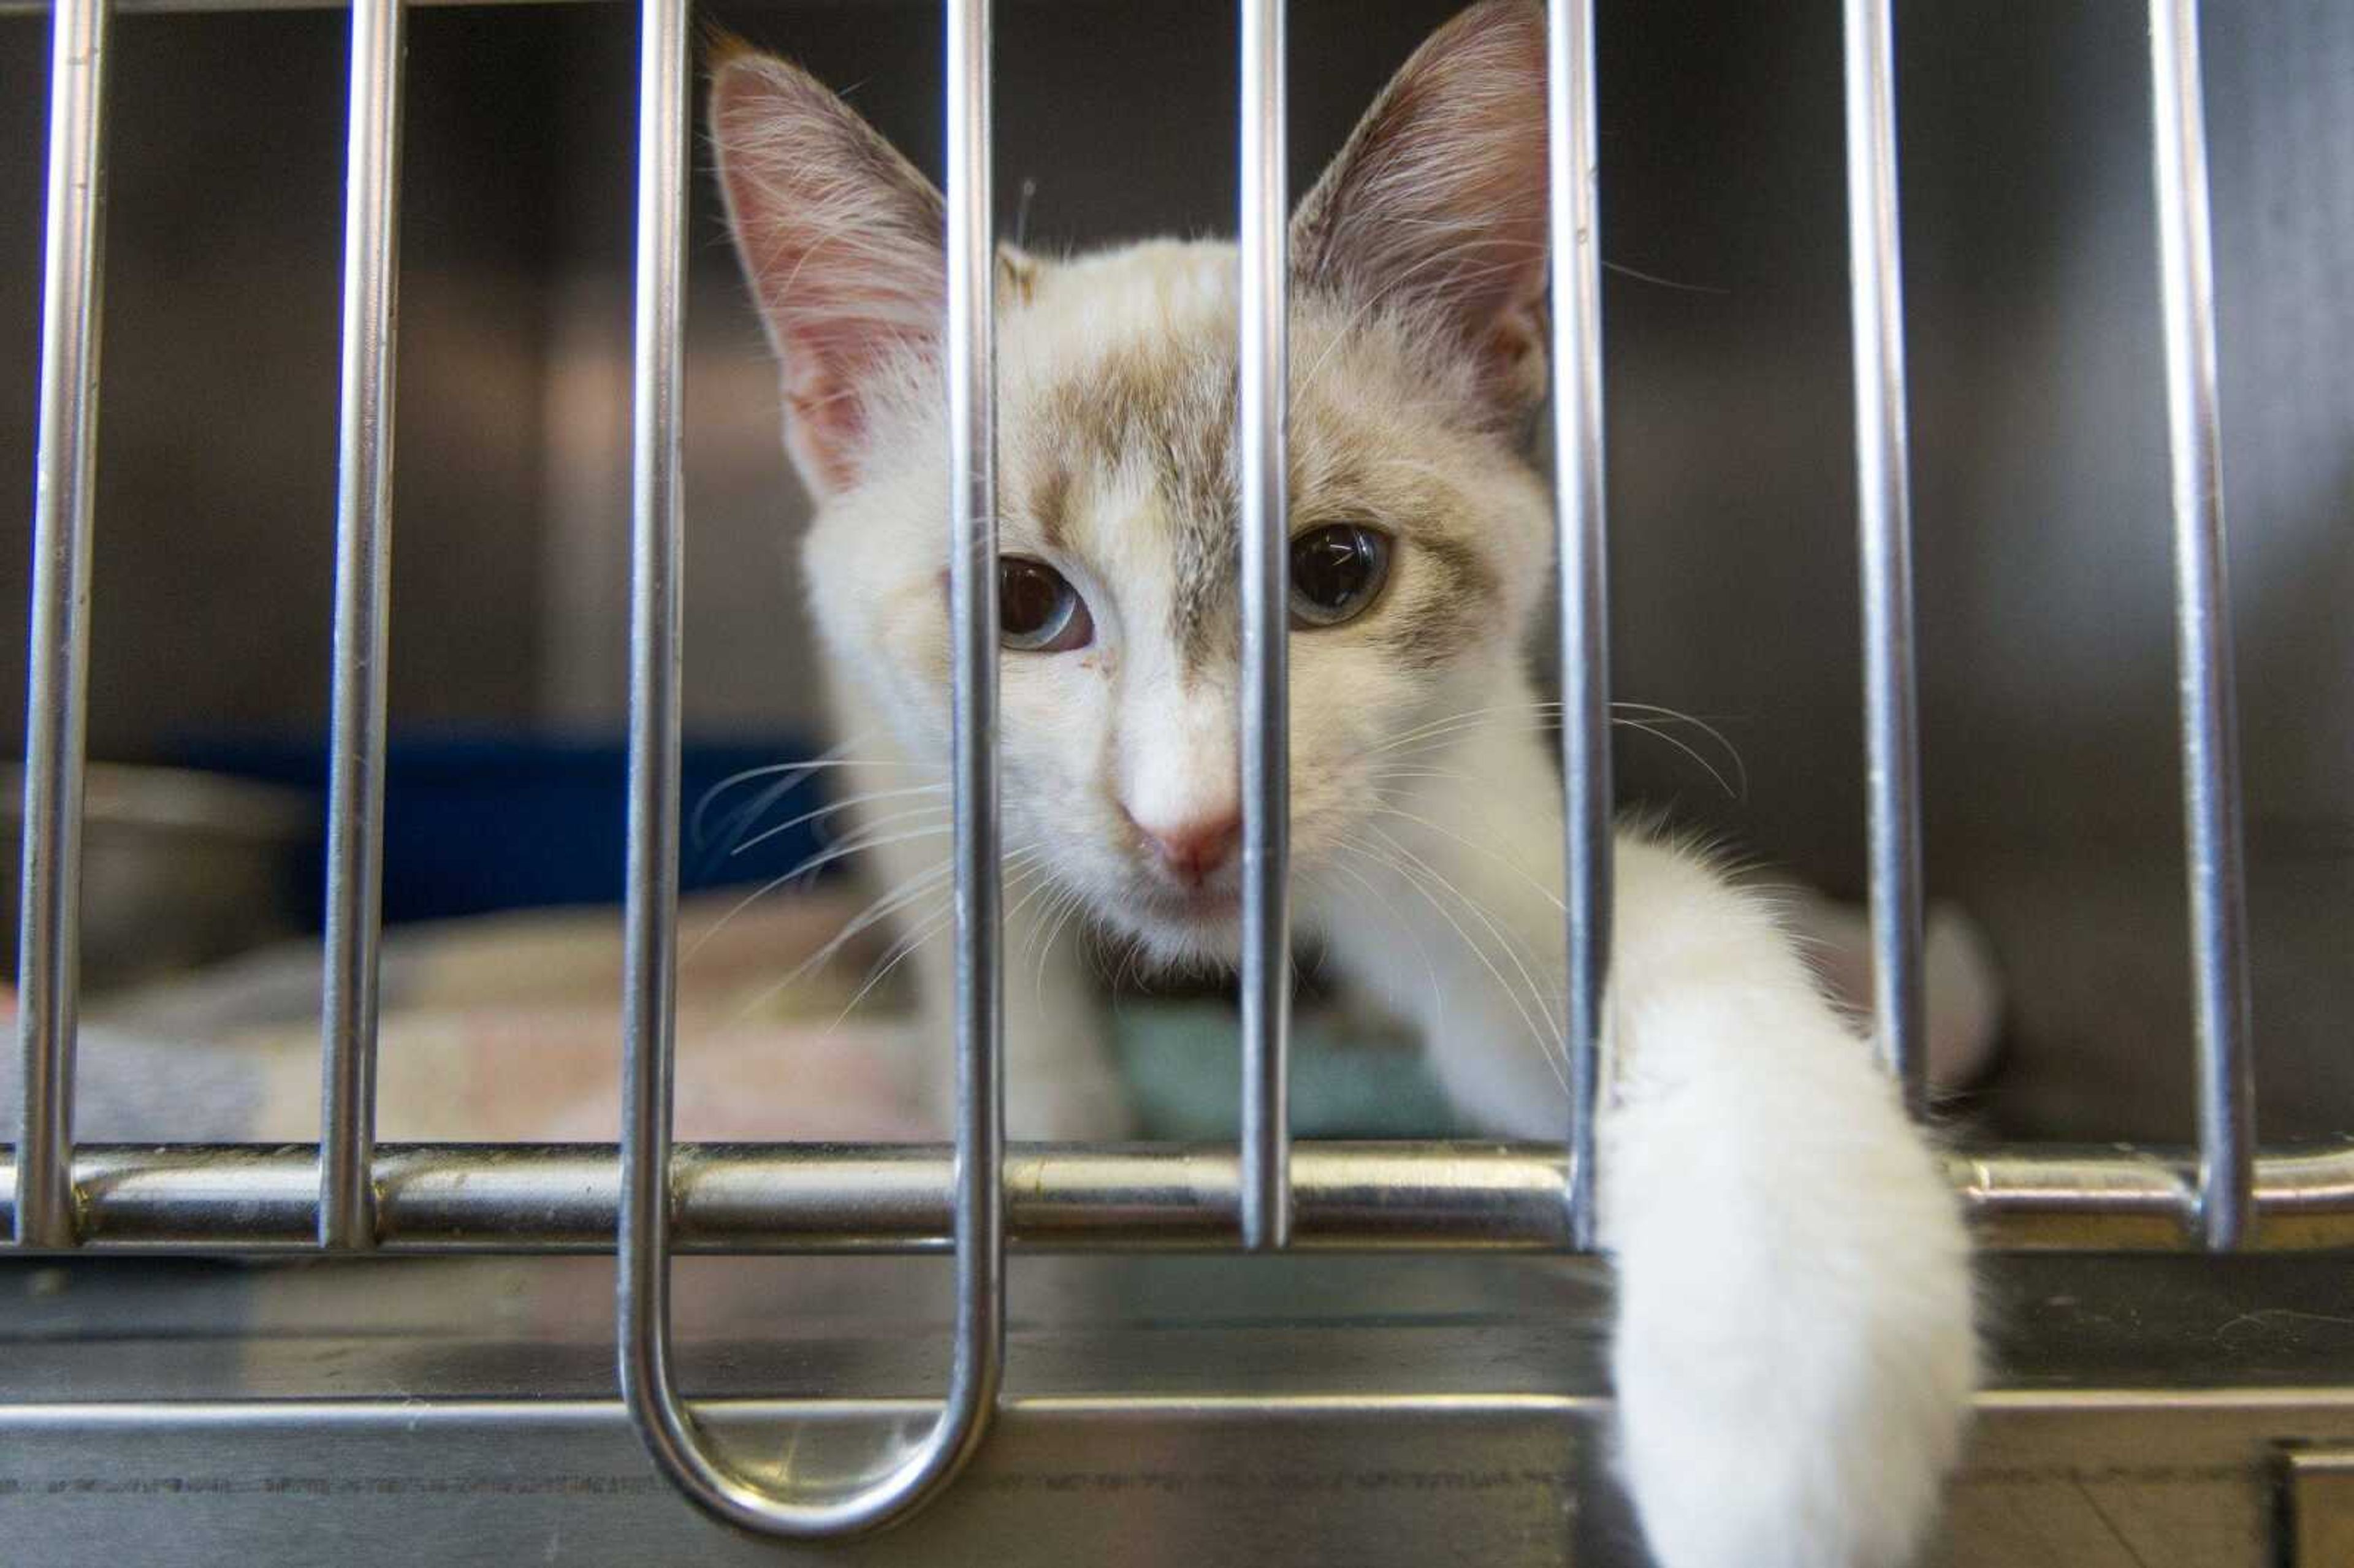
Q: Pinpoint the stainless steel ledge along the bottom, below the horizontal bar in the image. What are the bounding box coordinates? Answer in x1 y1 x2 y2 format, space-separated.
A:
0 1257 2354 1568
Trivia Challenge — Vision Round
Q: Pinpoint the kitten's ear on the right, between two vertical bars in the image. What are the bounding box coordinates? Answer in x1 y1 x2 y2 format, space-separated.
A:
1292 0 1547 414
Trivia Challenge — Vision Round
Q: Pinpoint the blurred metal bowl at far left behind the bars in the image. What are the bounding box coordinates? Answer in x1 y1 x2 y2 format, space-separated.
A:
0 763 320 991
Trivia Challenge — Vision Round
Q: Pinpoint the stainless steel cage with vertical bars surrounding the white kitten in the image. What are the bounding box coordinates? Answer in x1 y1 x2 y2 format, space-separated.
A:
0 0 2354 1563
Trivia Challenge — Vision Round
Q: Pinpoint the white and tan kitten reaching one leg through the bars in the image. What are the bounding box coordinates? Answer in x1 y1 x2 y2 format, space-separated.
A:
711 0 1978 1568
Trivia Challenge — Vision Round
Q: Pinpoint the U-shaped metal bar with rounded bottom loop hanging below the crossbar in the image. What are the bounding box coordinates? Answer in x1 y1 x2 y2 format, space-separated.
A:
617 0 1005 1537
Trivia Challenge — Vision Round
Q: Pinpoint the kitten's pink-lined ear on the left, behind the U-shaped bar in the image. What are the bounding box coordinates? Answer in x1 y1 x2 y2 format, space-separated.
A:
711 40 947 497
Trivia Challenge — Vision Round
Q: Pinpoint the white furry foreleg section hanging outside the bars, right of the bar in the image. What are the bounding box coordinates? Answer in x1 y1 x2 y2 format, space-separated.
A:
1601 838 1978 1568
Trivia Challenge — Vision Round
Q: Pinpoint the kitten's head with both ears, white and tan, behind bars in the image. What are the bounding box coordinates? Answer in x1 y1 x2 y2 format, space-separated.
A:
711 0 1552 958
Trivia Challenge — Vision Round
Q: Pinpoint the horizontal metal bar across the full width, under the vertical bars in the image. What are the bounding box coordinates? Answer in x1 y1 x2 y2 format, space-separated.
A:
0 1142 2354 1255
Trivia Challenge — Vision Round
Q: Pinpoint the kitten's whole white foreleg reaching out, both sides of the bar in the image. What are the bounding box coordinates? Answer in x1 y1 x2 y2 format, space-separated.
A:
1335 706 1978 1568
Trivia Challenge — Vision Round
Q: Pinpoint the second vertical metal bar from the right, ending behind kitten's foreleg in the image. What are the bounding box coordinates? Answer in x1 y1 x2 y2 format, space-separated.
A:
1846 0 1928 1114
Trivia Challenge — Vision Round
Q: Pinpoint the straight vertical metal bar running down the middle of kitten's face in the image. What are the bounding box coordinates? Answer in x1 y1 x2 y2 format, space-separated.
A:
1236 0 1292 1250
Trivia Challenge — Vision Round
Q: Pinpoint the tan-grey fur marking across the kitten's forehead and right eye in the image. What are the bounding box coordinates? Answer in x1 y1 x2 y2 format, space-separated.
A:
1015 252 1542 673
